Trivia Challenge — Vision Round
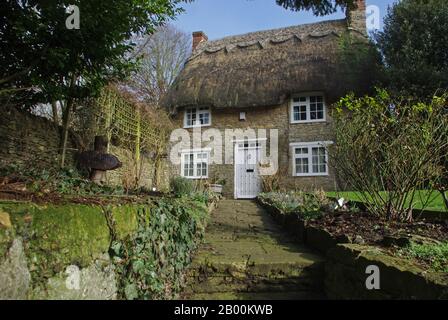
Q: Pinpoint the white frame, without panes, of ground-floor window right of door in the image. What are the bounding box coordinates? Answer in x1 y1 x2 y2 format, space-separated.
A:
290 141 333 177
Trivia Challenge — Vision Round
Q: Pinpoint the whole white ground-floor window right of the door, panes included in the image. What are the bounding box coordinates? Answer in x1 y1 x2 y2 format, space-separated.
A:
292 142 328 177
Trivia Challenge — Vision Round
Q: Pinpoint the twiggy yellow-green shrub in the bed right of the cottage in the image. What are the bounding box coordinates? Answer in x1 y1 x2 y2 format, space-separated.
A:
331 90 448 221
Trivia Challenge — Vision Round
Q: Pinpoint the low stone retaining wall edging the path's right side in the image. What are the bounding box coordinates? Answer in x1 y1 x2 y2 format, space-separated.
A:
258 199 448 300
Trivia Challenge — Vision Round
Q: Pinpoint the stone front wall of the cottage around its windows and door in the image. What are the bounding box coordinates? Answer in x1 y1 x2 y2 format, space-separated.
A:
173 103 336 197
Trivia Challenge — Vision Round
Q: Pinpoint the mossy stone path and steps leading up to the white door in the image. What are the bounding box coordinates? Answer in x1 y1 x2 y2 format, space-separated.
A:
183 200 324 300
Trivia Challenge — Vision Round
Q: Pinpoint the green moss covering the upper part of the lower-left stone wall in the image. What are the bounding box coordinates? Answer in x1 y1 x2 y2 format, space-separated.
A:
0 202 133 283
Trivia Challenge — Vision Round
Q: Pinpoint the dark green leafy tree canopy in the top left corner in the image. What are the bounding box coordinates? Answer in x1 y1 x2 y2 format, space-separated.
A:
0 0 191 104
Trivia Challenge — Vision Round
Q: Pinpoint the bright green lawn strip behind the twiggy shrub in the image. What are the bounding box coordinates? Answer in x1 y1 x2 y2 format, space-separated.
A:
327 190 446 211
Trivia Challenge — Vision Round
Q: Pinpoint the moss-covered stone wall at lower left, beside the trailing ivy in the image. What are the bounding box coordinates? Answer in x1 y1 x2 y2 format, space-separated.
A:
0 202 138 300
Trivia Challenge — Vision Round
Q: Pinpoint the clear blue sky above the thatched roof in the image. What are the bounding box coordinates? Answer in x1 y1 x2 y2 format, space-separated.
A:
173 0 397 40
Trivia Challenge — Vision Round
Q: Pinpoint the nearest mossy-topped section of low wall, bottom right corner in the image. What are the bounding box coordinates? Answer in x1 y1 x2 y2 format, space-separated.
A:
325 244 448 300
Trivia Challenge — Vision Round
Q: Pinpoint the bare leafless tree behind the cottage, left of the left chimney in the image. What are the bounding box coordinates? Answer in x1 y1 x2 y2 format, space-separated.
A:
125 24 191 107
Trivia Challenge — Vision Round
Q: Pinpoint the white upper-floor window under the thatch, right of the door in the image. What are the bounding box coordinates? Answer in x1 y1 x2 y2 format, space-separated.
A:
291 93 326 123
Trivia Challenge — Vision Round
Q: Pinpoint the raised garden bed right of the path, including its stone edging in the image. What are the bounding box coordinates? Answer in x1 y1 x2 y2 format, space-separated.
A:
257 195 448 299
